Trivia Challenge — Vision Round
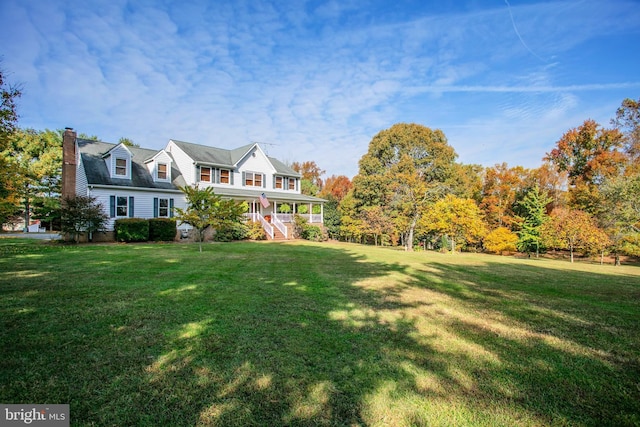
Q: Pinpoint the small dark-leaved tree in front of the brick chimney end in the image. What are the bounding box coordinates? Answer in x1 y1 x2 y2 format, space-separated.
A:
61 195 109 243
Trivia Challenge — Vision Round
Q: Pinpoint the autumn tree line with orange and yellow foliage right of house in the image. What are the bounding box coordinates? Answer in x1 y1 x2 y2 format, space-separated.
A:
293 99 640 264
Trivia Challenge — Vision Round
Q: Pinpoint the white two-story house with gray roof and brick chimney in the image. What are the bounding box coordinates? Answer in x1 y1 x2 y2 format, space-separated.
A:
62 128 325 239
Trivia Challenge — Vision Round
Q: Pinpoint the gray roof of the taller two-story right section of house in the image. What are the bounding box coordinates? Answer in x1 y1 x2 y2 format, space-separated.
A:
172 139 301 178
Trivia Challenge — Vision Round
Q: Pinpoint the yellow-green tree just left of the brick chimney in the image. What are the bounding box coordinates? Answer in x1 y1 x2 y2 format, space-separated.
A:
0 129 62 231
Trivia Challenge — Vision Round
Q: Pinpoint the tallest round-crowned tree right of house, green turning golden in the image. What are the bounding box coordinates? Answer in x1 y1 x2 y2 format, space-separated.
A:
353 123 456 250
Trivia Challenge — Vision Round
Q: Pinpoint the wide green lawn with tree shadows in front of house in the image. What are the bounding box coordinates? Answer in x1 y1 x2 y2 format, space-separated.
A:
0 239 640 426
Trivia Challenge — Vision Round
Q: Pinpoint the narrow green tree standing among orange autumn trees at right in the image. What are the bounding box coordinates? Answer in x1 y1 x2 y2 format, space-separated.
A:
517 185 552 258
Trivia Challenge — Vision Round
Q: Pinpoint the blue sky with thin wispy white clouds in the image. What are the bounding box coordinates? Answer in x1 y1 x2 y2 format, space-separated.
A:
0 0 640 177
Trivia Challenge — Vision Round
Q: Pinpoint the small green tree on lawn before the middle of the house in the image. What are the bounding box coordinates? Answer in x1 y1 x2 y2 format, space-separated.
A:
175 185 247 252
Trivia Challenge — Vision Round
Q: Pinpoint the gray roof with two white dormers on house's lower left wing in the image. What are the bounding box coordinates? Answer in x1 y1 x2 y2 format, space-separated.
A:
77 139 186 190
